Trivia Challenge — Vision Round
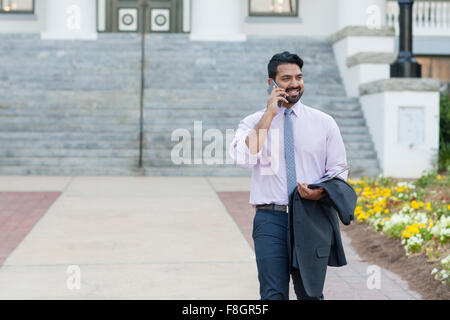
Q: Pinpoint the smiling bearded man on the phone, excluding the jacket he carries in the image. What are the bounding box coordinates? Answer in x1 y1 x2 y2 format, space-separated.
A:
230 51 347 300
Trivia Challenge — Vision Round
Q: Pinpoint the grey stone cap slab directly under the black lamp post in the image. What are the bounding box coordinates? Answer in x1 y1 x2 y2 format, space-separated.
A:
359 78 441 96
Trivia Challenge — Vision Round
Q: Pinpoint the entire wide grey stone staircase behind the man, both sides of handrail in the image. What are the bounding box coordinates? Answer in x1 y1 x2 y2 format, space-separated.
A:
0 34 379 177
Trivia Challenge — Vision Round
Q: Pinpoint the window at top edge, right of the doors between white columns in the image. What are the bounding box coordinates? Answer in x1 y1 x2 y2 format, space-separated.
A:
248 0 298 17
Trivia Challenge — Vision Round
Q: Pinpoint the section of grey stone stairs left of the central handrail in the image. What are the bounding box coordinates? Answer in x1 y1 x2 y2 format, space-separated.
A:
0 34 140 175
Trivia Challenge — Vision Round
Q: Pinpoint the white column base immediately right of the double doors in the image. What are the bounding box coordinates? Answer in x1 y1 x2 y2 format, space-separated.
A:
190 0 246 41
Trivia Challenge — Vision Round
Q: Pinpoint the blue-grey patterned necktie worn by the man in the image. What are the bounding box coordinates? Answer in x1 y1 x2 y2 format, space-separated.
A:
284 107 297 198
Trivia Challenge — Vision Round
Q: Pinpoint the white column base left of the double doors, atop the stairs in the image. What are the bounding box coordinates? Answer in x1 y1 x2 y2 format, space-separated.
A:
41 0 97 40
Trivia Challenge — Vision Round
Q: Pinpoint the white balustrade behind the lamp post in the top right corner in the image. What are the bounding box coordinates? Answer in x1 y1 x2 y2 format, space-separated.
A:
386 0 450 37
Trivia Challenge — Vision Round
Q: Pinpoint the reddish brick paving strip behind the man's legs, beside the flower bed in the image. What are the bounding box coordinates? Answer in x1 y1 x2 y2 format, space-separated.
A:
218 191 420 300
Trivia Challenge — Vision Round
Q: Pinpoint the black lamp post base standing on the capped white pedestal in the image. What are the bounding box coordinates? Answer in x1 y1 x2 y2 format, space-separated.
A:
391 0 422 78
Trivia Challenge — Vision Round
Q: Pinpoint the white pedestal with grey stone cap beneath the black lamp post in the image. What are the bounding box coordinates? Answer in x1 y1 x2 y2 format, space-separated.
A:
360 78 440 178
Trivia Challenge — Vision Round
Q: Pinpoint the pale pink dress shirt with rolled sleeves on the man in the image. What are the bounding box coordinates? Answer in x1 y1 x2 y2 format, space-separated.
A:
230 101 348 206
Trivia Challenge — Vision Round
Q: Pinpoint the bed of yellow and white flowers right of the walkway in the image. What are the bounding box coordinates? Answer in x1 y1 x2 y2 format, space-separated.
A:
348 172 450 285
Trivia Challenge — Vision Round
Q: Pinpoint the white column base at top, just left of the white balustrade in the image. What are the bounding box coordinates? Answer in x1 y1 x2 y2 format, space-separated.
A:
337 0 386 30
